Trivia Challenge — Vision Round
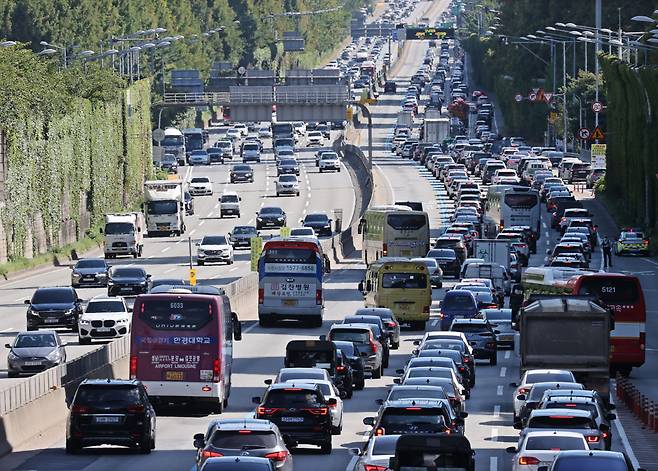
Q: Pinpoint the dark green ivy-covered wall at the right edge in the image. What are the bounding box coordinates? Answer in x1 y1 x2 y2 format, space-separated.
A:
601 56 658 228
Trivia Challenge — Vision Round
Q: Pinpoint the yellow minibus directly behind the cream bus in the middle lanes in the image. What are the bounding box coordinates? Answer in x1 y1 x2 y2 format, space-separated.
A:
359 257 432 330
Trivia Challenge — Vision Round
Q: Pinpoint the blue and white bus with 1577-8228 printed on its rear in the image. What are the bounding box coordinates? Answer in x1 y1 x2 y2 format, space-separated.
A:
258 237 329 327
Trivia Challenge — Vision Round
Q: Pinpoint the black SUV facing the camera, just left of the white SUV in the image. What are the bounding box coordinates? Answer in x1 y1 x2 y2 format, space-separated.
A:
25 286 82 332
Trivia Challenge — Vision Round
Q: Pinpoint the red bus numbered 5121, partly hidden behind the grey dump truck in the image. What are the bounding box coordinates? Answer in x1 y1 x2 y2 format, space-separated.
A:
567 273 647 376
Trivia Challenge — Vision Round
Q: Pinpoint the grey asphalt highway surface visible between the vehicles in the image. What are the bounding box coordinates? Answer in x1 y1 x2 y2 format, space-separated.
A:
0 1 658 471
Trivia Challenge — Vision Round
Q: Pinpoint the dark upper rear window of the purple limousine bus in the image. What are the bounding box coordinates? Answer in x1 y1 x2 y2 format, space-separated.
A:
139 298 213 330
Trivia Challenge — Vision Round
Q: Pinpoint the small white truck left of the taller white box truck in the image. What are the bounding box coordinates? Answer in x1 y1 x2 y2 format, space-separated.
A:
103 212 146 258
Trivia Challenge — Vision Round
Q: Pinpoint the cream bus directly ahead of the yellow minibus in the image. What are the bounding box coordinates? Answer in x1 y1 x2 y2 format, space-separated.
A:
358 205 430 265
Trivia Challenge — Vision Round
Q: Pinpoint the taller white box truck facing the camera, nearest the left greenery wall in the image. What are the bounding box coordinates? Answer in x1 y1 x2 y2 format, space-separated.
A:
144 180 185 235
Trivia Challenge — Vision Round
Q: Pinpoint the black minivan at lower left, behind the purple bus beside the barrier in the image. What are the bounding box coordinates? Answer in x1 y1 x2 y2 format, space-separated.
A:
66 379 155 453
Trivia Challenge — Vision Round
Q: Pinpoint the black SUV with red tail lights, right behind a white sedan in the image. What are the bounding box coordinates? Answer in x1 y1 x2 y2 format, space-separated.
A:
252 380 336 455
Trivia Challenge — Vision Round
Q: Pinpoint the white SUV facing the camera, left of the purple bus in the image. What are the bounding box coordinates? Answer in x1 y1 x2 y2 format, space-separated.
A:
78 296 131 345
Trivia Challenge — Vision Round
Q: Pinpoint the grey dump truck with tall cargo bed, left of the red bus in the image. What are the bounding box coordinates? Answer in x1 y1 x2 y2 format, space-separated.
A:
518 296 614 398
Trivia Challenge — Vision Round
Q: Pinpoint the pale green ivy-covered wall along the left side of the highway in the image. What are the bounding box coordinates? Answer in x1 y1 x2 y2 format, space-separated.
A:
0 81 153 262
